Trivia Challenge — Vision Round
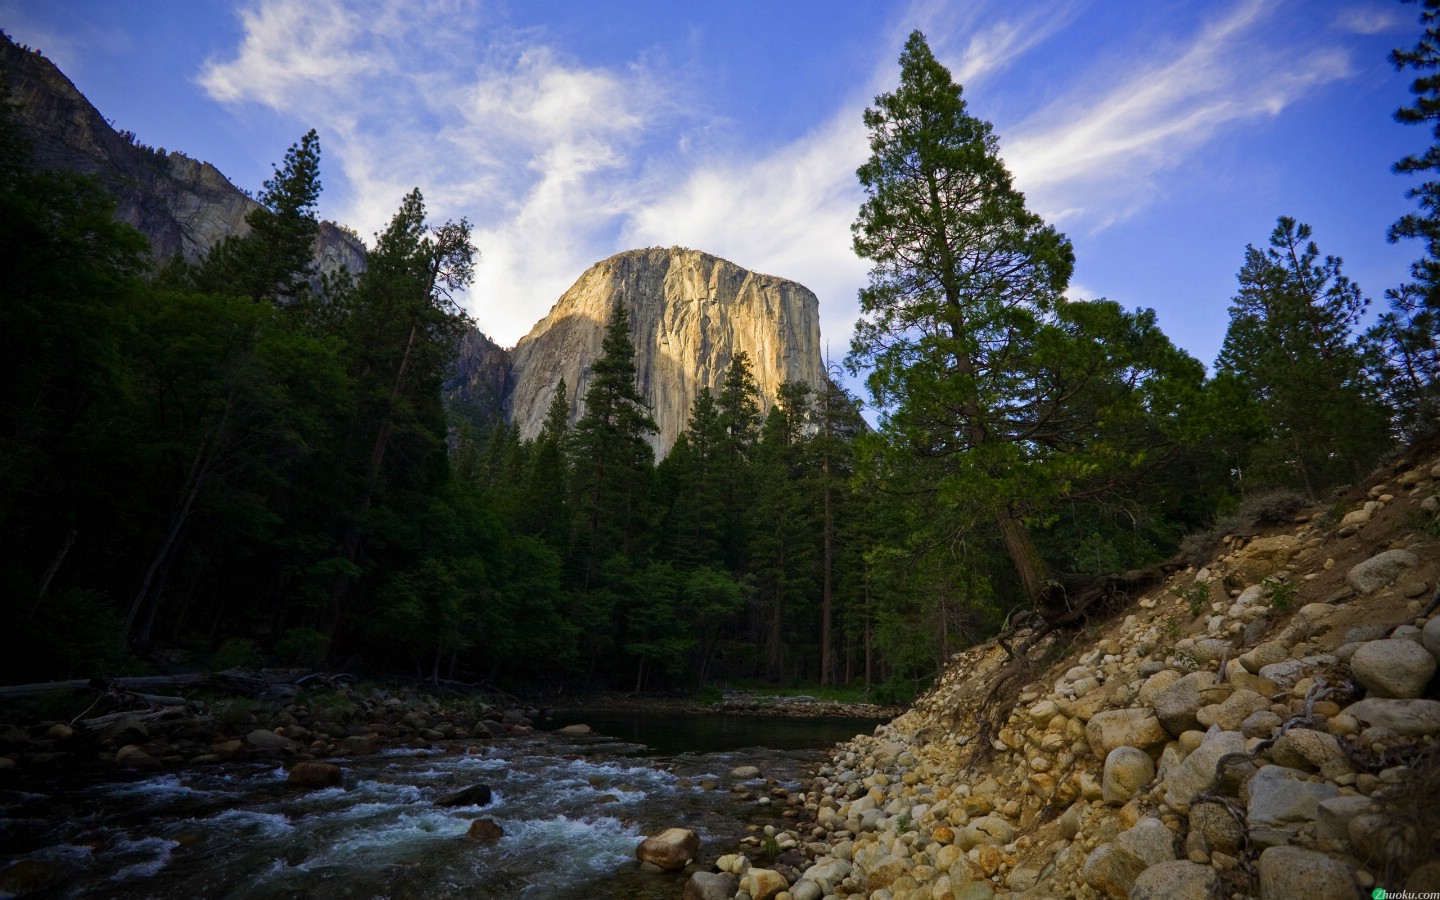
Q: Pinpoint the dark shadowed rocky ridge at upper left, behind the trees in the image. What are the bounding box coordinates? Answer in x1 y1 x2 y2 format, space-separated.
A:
0 36 364 272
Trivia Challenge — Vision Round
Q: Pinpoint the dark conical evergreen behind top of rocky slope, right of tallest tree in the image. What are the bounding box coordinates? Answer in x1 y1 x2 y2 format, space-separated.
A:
1215 216 1388 497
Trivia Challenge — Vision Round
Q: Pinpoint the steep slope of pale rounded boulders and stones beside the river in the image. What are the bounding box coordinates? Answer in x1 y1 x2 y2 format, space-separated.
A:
684 459 1440 900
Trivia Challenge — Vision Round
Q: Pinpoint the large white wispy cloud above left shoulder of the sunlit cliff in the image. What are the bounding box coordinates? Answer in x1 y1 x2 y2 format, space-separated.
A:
199 0 683 341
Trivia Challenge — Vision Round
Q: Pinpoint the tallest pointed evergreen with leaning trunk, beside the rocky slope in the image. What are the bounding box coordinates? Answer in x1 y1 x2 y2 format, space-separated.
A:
851 32 1074 607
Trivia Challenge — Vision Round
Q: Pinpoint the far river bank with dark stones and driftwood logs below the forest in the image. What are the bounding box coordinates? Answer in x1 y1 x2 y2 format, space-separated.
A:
0 672 903 783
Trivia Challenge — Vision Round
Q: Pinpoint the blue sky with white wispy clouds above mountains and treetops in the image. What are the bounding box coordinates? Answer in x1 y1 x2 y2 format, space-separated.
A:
0 0 1428 380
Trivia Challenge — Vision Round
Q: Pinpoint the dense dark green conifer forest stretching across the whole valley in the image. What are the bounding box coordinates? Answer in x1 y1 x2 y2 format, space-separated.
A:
0 17 1440 700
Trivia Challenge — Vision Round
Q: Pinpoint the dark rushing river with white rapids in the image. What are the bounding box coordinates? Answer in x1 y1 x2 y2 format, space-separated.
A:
0 714 876 900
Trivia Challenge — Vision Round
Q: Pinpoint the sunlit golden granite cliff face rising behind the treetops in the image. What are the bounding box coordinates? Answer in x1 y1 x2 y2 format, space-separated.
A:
508 248 825 454
